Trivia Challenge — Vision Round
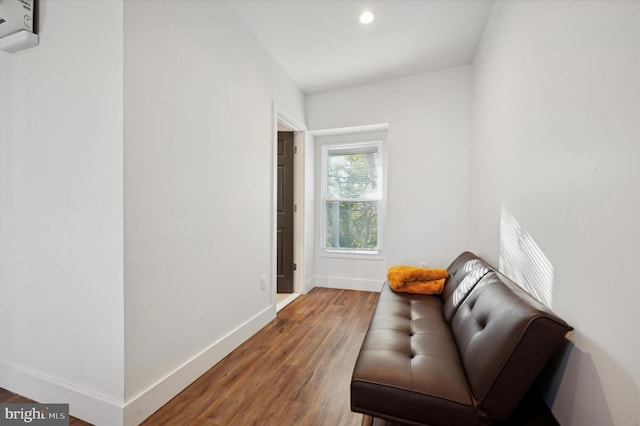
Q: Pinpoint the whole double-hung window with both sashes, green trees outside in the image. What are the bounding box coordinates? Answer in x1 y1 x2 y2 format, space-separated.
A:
320 131 385 255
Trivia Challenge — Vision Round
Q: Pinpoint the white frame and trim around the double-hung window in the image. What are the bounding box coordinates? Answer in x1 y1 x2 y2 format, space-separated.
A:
316 130 387 260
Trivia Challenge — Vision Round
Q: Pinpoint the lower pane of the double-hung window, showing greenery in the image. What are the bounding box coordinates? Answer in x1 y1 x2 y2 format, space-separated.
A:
326 201 378 250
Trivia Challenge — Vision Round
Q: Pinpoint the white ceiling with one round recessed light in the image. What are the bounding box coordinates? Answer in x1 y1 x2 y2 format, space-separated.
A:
227 0 493 94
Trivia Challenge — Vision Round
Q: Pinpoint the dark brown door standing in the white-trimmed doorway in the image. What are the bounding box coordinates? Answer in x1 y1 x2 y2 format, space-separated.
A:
277 132 294 293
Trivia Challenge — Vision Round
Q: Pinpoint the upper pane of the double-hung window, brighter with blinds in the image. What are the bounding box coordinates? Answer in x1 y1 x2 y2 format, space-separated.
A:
327 147 382 199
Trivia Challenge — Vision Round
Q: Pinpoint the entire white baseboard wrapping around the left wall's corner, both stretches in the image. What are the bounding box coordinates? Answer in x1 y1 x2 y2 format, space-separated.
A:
0 305 276 426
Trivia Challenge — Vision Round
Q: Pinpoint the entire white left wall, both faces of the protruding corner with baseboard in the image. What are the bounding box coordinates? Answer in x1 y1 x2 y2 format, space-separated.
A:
0 0 304 425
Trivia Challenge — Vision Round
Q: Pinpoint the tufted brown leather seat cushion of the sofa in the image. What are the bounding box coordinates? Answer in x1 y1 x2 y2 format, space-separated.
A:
351 284 476 425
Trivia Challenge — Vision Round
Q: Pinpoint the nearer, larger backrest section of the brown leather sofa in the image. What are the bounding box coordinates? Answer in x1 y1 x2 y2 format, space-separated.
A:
451 271 572 421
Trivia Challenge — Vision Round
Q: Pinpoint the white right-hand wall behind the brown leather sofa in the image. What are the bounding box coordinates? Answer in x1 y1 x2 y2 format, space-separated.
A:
471 1 640 426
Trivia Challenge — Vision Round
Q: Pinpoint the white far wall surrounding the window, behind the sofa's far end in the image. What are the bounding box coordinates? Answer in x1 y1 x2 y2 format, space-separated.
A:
307 66 471 290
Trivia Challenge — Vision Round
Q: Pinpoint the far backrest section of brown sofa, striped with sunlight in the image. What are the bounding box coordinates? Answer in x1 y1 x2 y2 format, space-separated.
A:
441 251 492 323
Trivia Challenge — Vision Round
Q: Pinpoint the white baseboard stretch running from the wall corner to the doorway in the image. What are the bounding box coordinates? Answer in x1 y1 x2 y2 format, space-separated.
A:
124 305 276 426
